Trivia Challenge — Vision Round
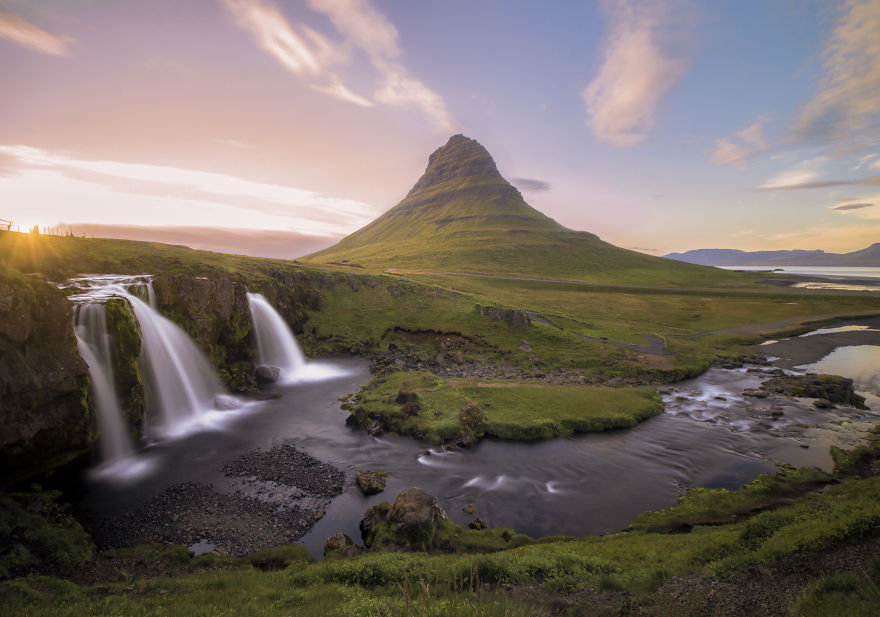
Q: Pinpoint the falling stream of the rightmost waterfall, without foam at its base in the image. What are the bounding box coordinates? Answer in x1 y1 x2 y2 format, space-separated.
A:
247 293 306 381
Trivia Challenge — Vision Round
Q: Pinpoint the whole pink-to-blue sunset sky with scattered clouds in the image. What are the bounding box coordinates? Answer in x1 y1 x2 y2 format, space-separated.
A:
0 0 880 257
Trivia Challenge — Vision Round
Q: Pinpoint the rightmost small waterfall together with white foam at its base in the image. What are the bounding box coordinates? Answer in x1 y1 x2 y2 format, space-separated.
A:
247 293 348 383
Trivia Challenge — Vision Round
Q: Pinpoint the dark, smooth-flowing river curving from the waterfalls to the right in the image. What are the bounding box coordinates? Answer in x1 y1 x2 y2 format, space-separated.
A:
82 322 880 556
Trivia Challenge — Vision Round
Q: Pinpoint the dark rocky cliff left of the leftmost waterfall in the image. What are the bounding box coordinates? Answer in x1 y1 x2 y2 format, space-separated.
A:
0 267 97 484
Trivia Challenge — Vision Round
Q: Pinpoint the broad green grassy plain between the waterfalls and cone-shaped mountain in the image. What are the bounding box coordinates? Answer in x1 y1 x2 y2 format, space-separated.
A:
0 232 880 382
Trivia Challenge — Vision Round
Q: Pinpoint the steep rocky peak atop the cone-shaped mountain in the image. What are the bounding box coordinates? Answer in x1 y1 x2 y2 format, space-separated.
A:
410 134 515 195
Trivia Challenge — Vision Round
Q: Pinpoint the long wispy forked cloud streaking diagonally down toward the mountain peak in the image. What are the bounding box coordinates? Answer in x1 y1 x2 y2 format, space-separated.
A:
222 0 455 131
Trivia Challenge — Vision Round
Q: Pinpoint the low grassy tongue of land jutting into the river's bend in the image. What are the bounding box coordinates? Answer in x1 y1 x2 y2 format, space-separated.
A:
349 372 663 443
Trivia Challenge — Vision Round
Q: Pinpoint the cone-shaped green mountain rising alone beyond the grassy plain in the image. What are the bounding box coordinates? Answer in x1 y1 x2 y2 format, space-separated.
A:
302 135 727 285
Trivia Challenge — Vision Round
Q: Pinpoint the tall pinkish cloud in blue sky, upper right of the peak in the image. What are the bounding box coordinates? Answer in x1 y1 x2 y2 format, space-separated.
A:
581 0 690 146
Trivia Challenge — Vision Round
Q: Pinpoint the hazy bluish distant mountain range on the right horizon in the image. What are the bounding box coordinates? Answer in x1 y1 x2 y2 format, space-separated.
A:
664 242 880 268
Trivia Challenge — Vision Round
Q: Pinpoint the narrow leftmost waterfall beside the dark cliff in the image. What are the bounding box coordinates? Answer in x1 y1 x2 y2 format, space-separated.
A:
74 302 134 464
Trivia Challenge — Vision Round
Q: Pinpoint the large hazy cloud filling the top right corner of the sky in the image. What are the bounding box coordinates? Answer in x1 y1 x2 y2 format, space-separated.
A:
792 0 880 149
